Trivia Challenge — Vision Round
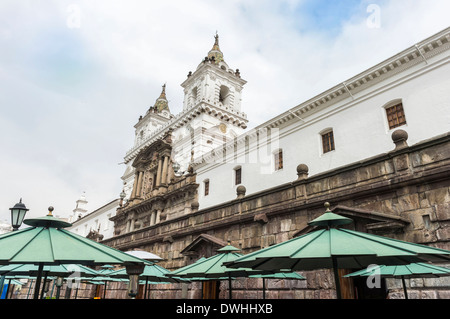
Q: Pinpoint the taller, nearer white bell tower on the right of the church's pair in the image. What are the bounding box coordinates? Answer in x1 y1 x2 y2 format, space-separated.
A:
172 34 248 168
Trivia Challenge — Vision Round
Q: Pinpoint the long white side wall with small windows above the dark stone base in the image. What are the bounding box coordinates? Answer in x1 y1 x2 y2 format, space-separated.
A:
196 35 450 209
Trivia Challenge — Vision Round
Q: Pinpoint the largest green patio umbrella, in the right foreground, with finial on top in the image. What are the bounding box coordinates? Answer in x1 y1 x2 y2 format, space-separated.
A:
225 203 450 299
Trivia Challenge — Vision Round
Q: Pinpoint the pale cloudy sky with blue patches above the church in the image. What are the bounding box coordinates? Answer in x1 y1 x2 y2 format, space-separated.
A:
0 0 450 222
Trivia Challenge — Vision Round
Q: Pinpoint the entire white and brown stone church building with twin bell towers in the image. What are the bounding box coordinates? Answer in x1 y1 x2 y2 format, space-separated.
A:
102 29 450 298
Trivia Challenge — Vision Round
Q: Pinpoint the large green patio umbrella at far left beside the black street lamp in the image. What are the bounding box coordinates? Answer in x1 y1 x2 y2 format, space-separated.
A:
0 207 148 299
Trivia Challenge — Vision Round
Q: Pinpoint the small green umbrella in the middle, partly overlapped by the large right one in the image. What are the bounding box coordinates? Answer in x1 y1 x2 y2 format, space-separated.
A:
167 244 280 299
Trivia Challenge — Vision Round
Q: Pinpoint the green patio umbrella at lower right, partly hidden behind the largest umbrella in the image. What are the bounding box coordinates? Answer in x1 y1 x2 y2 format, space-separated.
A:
344 263 450 299
